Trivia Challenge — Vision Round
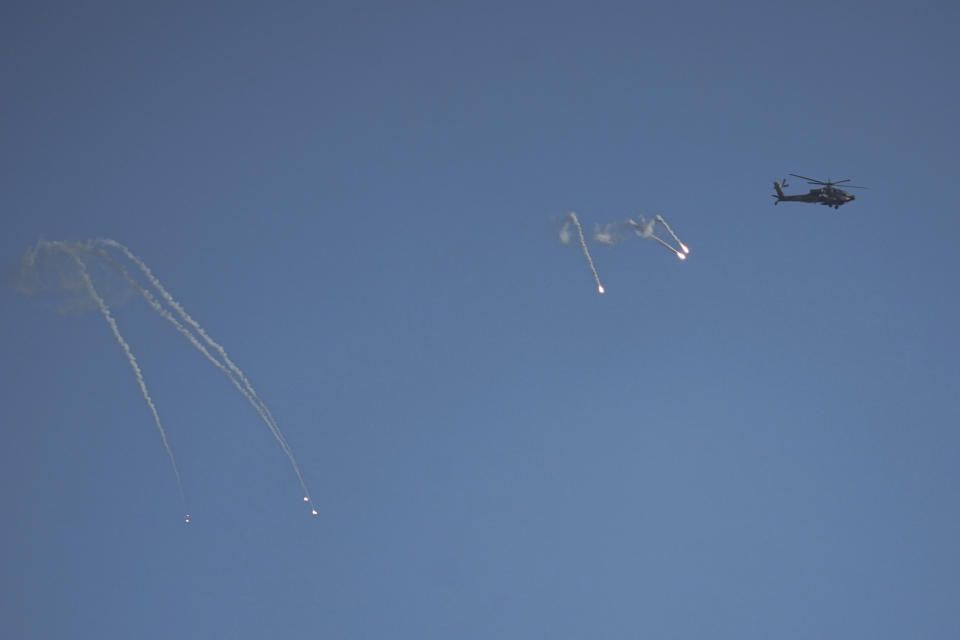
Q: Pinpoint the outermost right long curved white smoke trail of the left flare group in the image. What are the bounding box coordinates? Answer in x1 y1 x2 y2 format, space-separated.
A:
94 238 318 515
